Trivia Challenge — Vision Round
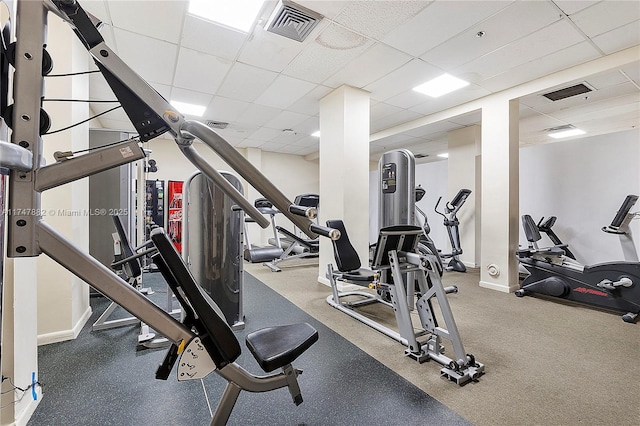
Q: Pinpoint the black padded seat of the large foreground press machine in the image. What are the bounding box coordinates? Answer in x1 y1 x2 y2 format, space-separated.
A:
246 322 318 373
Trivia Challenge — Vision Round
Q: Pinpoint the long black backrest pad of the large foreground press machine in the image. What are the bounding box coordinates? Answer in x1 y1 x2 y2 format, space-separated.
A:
151 228 242 368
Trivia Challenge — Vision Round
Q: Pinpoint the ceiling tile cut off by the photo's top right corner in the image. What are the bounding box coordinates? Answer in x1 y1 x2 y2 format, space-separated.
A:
570 1 640 37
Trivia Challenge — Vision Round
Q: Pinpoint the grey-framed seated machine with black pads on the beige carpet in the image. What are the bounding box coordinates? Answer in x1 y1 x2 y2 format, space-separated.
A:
327 220 484 385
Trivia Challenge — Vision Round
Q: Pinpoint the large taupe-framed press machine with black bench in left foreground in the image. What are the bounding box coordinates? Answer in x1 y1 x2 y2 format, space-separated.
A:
0 0 339 425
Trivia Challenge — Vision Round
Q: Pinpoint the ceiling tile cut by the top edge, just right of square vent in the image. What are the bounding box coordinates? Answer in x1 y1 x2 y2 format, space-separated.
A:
335 0 429 40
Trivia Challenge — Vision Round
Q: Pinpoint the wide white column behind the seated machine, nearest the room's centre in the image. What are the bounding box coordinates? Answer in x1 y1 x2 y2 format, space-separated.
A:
318 86 369 284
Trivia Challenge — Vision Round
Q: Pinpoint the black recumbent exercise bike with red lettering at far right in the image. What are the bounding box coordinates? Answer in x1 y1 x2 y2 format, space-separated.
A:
515 195 640 323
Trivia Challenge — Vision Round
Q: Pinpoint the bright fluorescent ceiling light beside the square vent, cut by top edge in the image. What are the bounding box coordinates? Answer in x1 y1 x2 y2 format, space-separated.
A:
189 0 264 33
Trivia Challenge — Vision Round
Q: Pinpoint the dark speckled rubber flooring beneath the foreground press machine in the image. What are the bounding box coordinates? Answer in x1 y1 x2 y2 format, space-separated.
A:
28 273 469 426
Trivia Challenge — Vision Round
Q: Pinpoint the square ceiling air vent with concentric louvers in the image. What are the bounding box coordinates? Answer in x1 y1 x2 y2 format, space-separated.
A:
266 0 323 42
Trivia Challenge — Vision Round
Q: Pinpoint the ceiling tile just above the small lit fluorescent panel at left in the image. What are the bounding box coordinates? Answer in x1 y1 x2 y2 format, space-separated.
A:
173 47 231 94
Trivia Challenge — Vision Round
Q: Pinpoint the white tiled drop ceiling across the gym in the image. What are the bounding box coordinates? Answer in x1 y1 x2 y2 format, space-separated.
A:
80 0 640 161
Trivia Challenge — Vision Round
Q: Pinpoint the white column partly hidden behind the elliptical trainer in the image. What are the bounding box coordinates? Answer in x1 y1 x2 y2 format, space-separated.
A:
448 126 481 268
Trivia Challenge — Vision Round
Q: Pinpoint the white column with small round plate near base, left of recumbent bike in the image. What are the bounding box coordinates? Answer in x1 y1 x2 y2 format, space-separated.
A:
480 97 519 292
